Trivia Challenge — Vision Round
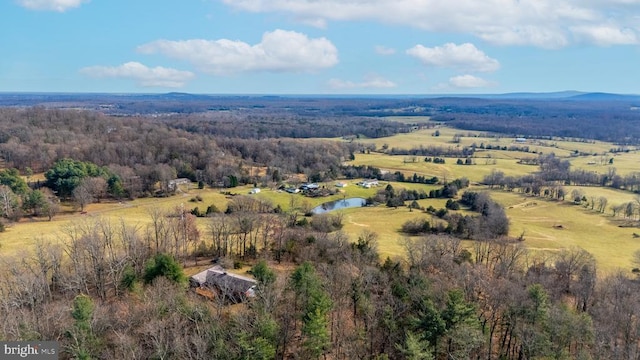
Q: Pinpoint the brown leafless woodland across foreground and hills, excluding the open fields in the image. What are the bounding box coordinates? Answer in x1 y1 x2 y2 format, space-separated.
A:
0 94 640 360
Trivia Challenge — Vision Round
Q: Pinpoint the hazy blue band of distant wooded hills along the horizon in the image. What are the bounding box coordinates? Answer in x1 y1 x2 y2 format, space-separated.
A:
0 91 640 115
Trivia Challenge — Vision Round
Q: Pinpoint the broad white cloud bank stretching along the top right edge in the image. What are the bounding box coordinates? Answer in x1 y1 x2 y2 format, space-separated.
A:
223 0 640 48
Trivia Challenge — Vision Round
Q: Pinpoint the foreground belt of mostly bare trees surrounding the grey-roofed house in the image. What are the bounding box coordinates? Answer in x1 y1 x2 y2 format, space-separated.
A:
0 204 640 359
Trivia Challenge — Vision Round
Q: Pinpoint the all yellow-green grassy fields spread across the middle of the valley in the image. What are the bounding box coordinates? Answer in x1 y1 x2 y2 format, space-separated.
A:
0 121 640 272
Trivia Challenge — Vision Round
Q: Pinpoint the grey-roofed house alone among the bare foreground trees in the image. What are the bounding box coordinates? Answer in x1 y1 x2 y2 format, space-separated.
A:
189 265 257 303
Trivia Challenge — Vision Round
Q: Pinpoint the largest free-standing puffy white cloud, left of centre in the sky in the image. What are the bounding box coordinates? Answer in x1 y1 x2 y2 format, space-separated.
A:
138 30 338 75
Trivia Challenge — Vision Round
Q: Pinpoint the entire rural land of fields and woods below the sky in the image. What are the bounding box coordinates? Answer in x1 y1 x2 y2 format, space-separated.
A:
0 95 640 359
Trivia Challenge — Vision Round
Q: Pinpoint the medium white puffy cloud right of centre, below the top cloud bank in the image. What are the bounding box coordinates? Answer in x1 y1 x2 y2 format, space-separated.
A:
407 43 500 71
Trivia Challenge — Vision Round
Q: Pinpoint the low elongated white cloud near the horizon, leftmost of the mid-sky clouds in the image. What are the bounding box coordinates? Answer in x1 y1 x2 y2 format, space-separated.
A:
80 61 195 88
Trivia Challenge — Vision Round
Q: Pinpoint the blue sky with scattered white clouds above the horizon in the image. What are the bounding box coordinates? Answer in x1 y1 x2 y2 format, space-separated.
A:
0 0 640 95
